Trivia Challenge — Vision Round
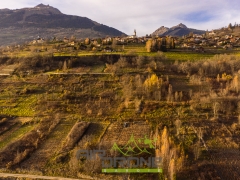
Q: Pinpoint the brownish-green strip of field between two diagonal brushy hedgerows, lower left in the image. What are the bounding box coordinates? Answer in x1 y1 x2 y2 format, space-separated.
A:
20 119 75 171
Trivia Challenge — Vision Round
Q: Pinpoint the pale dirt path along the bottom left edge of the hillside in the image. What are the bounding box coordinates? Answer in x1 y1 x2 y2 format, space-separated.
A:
0 173 83 180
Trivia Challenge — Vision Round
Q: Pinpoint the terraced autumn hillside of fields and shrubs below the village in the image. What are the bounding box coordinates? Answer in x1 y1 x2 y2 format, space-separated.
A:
0 49 240 180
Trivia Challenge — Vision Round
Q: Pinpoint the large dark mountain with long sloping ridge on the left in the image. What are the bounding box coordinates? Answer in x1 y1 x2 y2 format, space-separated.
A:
0 4 126 45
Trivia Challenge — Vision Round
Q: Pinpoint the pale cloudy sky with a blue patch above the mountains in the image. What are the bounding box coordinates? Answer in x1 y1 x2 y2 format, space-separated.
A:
0 0 240 36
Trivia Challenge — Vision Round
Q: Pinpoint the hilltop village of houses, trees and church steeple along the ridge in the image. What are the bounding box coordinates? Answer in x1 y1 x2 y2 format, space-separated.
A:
0 24 240 54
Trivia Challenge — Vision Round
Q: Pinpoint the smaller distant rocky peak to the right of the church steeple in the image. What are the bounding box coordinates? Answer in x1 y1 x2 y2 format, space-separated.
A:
152 23 205 36
